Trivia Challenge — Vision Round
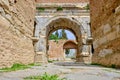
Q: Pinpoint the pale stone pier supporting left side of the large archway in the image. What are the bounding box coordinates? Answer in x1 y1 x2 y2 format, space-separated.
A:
35 16 47 63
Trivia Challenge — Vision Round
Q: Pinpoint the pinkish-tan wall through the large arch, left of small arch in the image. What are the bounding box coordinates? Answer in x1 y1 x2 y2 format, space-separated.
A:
48 40 66 60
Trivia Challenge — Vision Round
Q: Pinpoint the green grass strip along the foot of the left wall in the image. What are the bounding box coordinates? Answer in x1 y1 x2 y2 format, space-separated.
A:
0 63 40 72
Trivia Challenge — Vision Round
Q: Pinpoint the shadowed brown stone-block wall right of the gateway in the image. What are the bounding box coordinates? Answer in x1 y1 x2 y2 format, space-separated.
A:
90 0 120 67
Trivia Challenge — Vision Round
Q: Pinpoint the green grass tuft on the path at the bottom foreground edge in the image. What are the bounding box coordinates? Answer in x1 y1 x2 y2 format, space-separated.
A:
24 73 66 80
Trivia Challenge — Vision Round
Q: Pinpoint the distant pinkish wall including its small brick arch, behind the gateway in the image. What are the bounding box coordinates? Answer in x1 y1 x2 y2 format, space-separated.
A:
47 40 77 61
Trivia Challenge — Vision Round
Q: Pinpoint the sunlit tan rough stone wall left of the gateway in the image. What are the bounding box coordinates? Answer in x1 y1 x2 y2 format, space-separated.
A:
0 0 35 67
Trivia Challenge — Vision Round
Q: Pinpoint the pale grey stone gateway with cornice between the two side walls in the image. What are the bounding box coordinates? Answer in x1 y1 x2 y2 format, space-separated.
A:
34 3 91 62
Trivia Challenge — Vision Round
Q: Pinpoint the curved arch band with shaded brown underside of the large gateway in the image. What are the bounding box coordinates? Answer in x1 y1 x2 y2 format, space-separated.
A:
46 16 82 60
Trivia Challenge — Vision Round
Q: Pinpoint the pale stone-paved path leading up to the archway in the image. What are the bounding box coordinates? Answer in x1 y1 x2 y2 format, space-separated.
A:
0 62 120 80
